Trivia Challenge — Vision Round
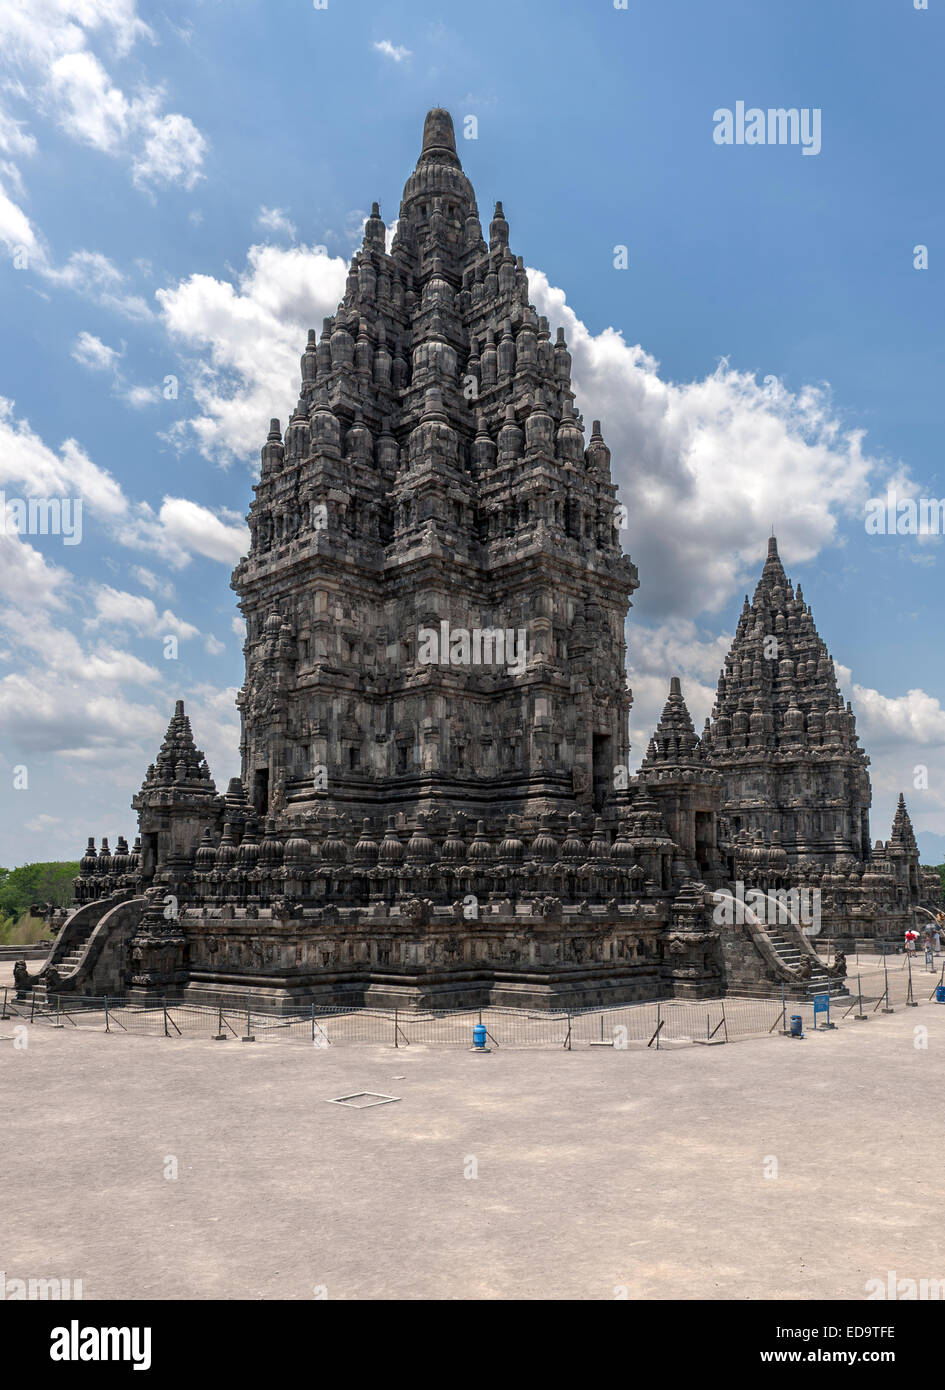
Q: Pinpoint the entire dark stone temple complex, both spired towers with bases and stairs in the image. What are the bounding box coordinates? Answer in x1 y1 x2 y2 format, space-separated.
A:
21 110 938 1008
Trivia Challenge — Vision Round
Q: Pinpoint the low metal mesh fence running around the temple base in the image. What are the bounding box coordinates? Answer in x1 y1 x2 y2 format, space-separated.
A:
0 973 945 1051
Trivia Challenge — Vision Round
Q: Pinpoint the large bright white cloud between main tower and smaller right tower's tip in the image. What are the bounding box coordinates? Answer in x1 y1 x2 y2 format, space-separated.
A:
528 271 902 619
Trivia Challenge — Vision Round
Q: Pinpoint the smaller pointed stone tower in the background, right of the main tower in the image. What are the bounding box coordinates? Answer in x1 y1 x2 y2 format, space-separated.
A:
702 537 870 872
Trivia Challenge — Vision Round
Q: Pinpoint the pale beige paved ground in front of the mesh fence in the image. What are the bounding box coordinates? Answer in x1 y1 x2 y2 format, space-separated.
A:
0 1005 945 1300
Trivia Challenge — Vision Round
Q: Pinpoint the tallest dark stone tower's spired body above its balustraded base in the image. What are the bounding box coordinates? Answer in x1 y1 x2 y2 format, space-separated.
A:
232 110 638 826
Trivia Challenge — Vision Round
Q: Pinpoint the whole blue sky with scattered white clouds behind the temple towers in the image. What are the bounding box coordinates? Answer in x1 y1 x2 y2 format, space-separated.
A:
0 0 945 863
